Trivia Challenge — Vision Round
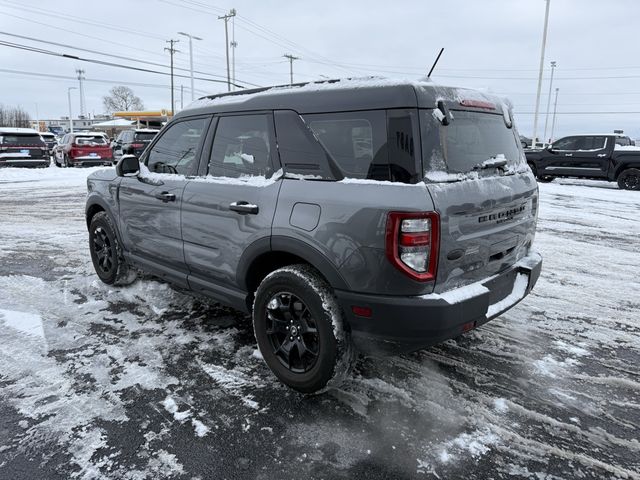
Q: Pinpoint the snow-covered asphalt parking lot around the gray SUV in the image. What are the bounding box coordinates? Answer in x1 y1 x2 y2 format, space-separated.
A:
0 168 640 479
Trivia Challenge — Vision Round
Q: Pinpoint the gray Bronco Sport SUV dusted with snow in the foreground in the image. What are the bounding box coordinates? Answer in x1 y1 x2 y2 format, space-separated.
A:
86 80 542 392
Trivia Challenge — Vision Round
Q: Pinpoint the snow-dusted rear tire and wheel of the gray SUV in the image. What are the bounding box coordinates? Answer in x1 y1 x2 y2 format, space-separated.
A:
253 265 353 393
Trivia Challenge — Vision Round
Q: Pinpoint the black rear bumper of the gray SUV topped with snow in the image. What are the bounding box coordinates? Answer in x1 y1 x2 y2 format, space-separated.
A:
335 252 542 353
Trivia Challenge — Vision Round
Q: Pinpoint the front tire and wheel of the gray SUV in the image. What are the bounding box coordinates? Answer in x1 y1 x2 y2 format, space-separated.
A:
89 212 136 285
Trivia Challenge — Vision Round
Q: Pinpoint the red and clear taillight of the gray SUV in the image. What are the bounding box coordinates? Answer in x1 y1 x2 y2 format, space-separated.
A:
385 212 440 282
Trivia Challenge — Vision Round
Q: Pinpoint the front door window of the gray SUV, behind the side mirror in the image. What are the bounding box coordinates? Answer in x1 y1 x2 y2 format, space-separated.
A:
146 118 208 175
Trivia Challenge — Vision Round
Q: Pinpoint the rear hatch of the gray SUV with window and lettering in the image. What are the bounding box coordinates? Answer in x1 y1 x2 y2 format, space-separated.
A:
420 100 538 293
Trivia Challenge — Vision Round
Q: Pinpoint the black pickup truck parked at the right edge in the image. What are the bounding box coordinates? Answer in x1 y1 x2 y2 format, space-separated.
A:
526 133 640 190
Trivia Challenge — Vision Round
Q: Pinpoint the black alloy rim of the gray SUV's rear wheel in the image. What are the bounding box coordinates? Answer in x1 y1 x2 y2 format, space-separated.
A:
266 292 320 373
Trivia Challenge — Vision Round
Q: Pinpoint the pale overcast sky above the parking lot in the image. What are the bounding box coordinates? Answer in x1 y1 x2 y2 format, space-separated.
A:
0 0 640 138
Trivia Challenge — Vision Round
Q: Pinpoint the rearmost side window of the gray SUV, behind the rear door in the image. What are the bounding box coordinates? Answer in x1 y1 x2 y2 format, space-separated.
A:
304 110 388 180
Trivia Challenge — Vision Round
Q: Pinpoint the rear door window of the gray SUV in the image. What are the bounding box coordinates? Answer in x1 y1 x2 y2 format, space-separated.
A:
208 114 272 178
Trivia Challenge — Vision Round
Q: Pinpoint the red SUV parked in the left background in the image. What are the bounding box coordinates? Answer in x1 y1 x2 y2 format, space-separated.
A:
53 133 113 167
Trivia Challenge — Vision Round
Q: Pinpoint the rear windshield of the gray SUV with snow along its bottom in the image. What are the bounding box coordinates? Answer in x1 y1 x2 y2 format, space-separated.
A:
420 110 523 176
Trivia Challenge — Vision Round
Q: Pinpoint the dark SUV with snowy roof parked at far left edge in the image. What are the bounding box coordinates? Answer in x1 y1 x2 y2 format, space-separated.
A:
0 127 49 167
